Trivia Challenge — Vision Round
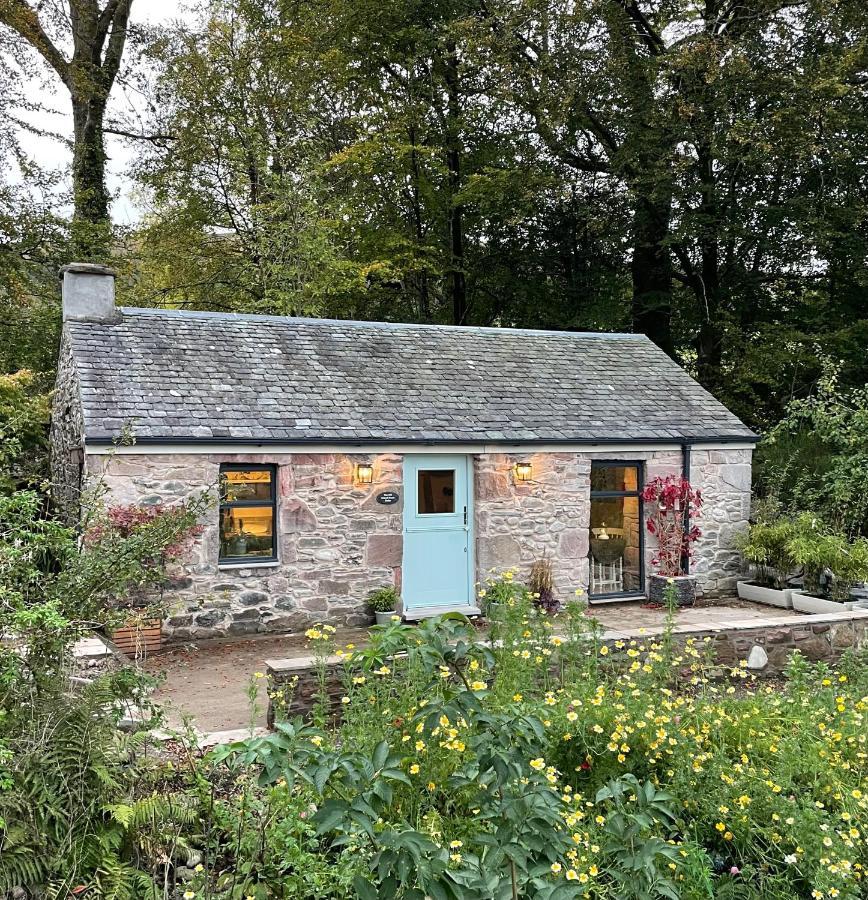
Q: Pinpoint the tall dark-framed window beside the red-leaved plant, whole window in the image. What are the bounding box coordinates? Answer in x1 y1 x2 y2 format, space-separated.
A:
588 460 645 600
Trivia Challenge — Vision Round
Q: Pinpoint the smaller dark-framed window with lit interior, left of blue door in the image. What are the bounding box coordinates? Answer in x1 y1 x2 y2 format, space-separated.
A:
219 464 277 563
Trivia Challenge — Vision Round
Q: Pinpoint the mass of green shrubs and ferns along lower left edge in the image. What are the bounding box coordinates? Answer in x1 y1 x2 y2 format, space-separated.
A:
0 491 214 900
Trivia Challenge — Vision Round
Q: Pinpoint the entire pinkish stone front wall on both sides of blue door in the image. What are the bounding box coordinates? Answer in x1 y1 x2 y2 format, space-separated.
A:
87 450 750 640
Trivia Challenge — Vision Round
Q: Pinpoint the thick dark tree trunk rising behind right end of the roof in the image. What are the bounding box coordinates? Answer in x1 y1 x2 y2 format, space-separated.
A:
631 196 675 356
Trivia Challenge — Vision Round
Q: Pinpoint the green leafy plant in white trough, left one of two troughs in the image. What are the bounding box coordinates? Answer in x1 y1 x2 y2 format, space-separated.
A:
736 518 796 609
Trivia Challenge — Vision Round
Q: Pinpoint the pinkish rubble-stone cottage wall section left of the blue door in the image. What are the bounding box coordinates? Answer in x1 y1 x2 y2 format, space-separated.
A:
88 454 403 640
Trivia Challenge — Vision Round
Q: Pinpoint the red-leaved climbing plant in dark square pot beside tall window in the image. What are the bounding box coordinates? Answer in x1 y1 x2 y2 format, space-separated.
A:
642 475 702 606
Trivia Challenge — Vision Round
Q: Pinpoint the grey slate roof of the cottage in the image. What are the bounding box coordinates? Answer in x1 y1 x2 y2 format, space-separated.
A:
66 308 755 444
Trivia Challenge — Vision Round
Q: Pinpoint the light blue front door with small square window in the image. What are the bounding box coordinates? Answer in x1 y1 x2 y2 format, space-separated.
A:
401 454 473 613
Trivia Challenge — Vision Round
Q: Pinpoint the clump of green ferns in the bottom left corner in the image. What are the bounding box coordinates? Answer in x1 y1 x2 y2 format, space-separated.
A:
0 679 173 900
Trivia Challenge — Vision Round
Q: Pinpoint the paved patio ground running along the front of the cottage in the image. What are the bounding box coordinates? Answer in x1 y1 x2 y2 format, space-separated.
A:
144 600 799 733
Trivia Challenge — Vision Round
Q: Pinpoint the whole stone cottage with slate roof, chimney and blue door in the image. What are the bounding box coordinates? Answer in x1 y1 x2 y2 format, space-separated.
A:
52 264 756 639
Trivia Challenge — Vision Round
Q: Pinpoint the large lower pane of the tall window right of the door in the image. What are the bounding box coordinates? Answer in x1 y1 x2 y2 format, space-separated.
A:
589 497 642 596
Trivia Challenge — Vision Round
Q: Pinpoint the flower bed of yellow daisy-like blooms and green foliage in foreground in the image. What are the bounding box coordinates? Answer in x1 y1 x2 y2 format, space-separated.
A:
176 584 868 900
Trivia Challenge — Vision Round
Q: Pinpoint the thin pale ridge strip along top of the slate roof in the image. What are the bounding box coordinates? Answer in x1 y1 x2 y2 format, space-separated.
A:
119 306 650 341
